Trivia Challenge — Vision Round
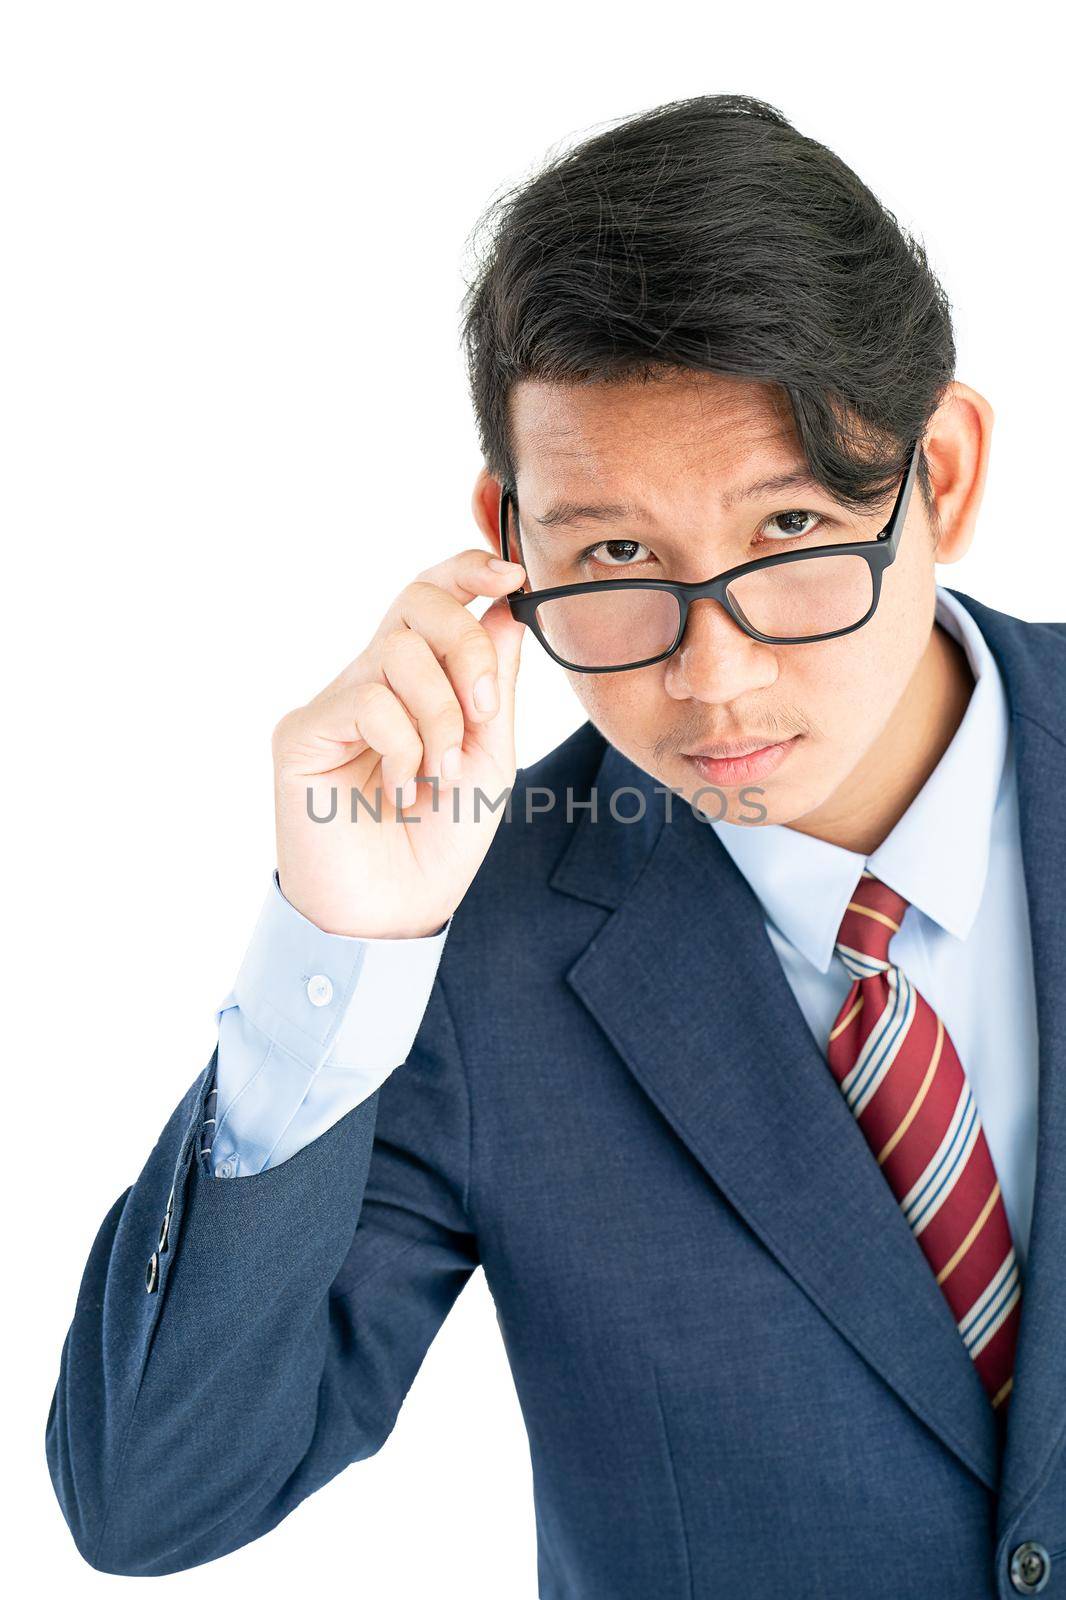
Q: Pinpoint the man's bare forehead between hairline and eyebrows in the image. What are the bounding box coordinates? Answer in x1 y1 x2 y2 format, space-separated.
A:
509 373 799 502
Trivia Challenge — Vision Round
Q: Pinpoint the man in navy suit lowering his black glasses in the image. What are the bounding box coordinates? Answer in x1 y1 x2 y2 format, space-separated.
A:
48 96 1066 1600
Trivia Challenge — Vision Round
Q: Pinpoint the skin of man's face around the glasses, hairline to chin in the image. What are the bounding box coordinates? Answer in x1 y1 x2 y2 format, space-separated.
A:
511 374 935 824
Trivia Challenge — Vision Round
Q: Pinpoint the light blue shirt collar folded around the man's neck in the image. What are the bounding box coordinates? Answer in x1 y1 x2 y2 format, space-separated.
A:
711 586 1010 973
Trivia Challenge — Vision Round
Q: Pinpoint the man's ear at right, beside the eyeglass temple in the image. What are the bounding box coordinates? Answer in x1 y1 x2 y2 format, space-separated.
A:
924 382 996 562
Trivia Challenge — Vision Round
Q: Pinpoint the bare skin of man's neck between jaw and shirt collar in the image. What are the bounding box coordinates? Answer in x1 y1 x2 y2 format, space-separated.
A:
787 622 973 856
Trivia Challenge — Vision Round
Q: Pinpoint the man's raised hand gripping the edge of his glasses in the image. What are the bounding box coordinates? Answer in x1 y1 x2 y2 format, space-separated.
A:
272 550 525 938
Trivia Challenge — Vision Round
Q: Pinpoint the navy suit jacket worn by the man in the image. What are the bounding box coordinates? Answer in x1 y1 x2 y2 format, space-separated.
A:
46 595 1066 1600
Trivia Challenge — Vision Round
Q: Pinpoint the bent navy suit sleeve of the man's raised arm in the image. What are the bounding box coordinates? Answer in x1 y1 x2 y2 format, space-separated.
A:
46 978 479 1576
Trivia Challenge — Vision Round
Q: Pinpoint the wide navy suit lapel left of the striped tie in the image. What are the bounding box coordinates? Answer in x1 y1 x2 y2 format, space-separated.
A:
551 732 999 1488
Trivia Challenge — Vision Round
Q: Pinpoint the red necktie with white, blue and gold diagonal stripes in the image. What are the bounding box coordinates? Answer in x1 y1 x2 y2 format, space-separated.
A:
828 872 1021 1443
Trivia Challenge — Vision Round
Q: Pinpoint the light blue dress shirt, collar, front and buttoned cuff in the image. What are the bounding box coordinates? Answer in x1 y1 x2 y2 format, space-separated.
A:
210 587 1037 1264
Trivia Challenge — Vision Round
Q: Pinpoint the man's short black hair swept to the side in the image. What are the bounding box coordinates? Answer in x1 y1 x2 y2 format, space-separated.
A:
461 94 956 531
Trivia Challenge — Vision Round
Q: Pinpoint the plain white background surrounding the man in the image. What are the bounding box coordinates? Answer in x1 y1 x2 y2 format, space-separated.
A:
0 0 1066 1600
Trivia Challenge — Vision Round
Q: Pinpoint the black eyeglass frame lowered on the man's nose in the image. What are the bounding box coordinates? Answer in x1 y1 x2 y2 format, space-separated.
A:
499 438 922 672
